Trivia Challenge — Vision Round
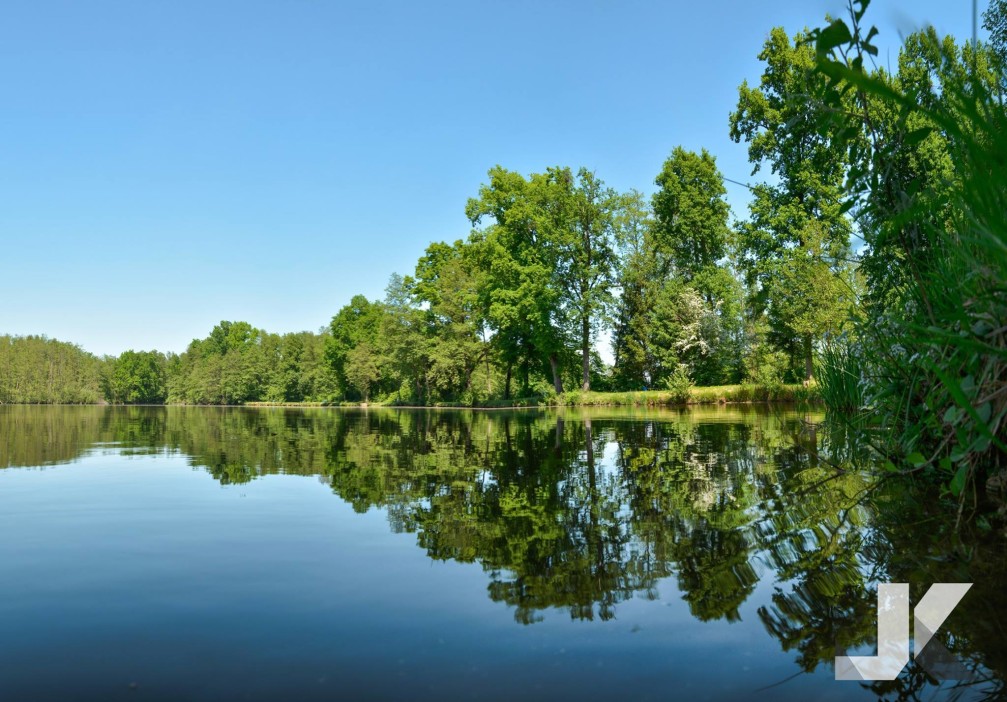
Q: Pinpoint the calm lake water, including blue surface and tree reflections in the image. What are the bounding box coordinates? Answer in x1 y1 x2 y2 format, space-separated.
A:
0 407 1007 701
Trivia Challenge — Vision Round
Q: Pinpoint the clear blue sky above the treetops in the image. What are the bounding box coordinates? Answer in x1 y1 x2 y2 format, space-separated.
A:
0 0 986 354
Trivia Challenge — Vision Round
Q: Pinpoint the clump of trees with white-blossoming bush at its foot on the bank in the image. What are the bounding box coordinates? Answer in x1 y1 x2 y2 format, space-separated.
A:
614 147 741 388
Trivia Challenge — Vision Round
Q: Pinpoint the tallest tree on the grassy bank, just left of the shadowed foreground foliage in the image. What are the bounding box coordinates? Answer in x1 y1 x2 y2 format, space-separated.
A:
730 27 852 379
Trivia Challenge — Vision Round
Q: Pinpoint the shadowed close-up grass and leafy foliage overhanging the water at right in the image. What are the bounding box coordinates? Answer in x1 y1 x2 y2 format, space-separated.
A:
817 2 1007 497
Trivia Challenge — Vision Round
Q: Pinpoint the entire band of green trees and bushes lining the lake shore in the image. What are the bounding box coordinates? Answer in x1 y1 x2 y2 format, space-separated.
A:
0 0 1007 487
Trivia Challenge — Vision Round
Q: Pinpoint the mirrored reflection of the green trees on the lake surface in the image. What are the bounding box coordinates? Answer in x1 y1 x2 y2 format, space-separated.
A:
0 407 1007 699
